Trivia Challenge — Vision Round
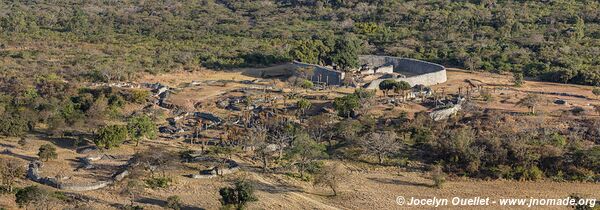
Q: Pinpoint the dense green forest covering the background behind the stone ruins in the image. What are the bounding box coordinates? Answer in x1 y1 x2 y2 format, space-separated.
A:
0 0 600 85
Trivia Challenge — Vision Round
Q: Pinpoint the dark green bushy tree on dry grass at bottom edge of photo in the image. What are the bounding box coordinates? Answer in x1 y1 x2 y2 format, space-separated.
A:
219 180 258 210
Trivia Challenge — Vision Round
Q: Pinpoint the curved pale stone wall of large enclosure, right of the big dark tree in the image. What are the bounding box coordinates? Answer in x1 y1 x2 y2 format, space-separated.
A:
359 55 447 89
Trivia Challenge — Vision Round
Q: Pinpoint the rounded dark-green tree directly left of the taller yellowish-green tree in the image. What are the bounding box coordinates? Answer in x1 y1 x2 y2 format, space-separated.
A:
94 125 128 149
